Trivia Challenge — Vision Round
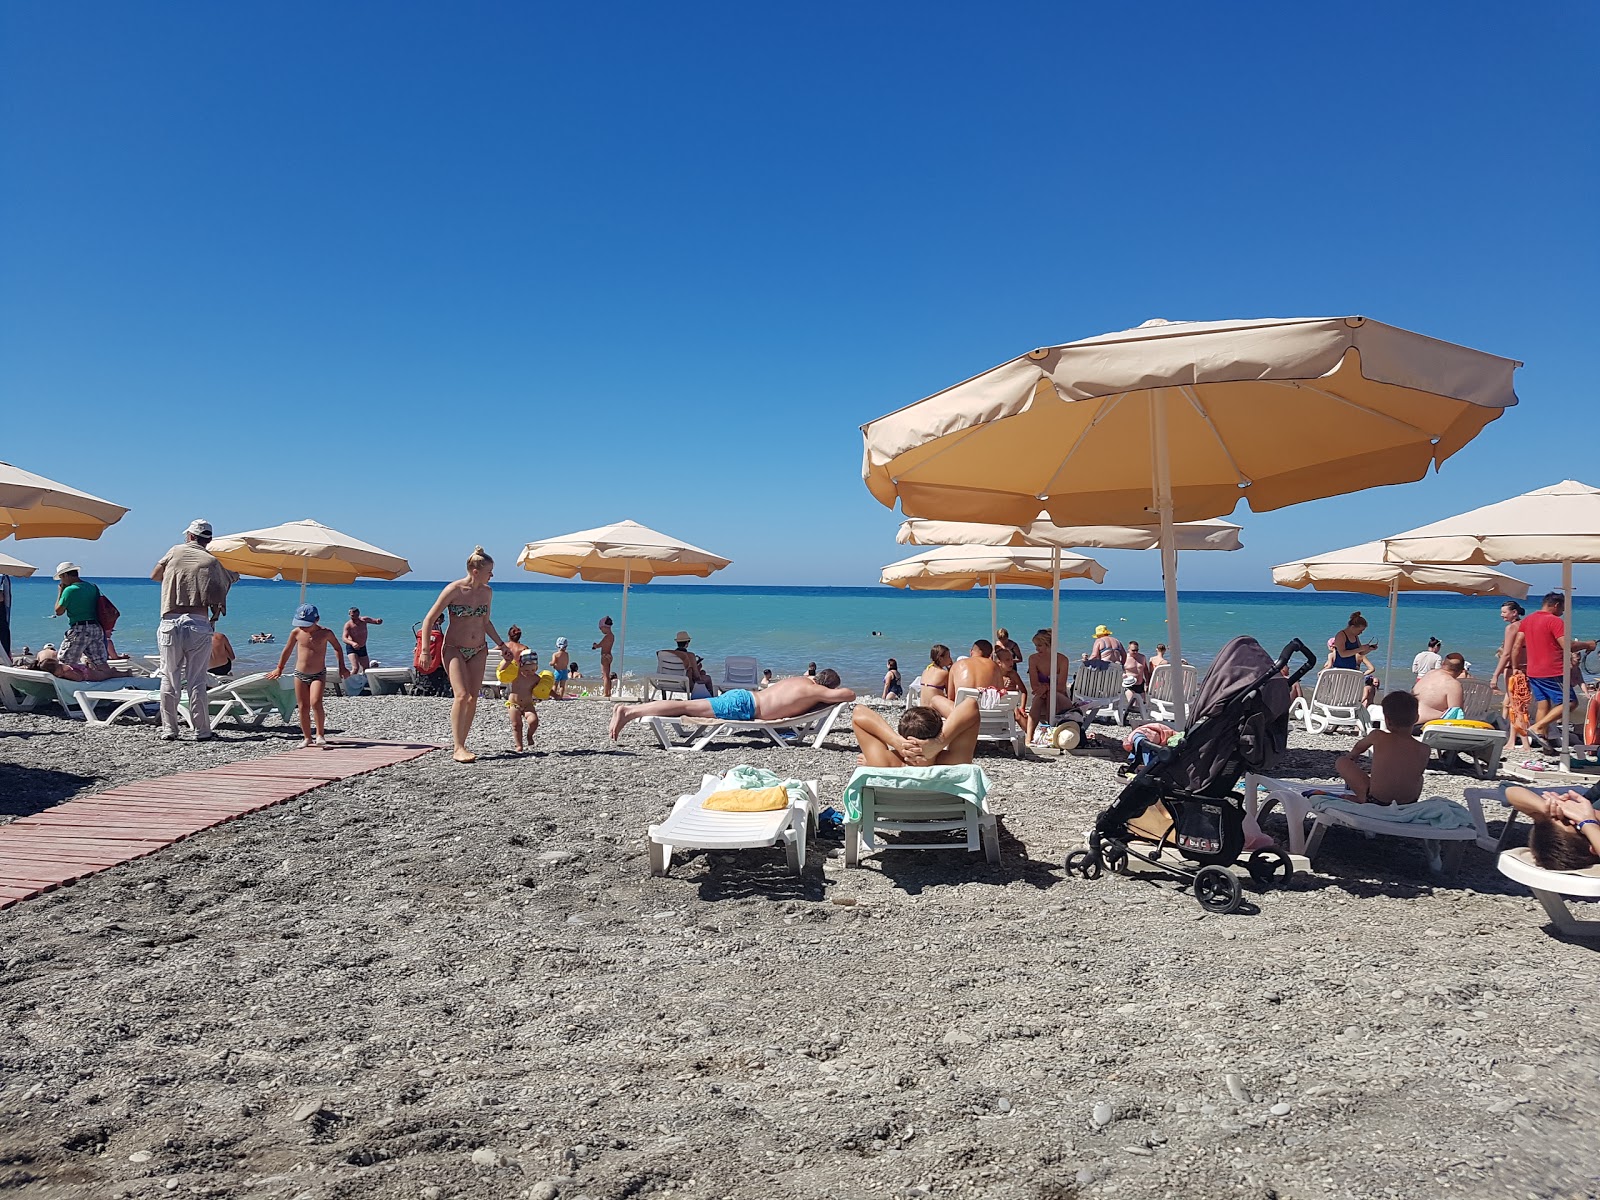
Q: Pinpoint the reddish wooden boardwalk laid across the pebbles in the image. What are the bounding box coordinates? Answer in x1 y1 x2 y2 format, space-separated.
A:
0 742 438 909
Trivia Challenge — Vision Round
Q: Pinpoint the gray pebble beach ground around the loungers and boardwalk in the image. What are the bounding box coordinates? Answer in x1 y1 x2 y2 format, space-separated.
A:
0 698 1600 1200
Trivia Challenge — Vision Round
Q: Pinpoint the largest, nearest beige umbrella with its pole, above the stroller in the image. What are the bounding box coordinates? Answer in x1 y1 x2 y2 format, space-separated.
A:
861 317 1520 717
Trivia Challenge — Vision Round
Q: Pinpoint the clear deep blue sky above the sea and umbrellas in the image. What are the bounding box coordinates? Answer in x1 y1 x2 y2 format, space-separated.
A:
0 0 1600 587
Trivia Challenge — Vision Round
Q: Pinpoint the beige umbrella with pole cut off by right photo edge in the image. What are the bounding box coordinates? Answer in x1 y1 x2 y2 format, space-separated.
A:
1384 480 1600 770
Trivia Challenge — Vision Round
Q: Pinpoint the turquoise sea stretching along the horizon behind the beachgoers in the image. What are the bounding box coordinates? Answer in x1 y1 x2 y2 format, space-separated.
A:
11 578 1600 693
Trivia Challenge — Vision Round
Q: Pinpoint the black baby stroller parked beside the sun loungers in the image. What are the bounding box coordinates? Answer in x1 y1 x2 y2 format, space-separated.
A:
1066 637 1317 912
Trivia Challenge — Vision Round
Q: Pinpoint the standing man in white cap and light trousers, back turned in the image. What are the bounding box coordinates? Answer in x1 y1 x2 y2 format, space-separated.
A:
150 520 237 742
